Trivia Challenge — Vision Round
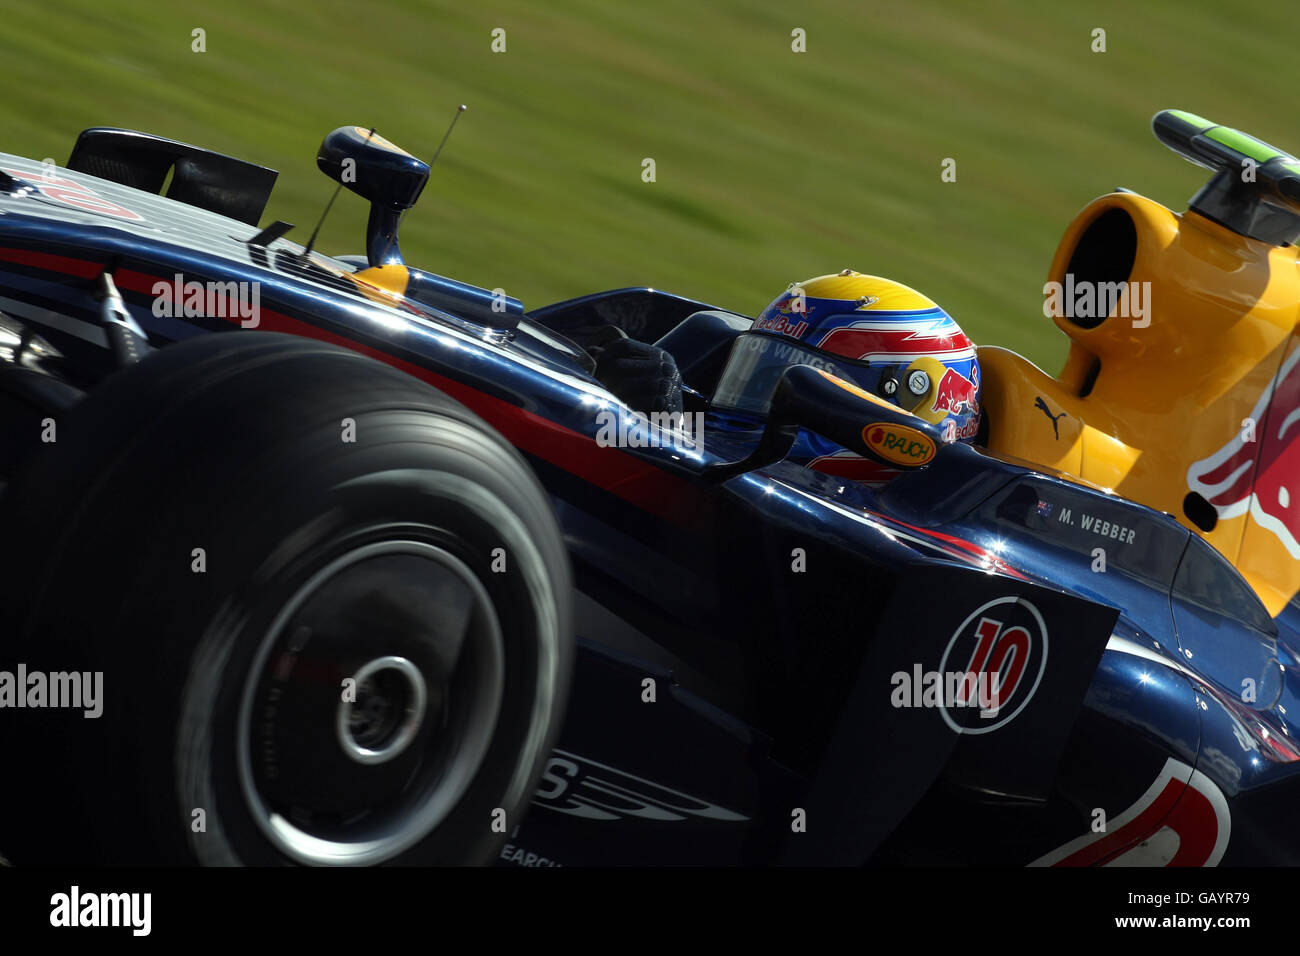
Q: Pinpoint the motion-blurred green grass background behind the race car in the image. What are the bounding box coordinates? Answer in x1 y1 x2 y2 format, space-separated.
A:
0 0 1300 371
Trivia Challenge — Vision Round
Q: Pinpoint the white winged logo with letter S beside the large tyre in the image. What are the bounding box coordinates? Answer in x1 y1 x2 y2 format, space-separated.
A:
533 750 749 823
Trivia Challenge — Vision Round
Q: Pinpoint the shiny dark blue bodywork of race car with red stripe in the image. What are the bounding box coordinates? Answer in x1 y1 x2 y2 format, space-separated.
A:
0 143 1300 865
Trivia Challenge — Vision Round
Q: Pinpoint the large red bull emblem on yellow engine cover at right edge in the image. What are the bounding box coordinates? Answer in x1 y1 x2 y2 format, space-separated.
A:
1187 347 1300 558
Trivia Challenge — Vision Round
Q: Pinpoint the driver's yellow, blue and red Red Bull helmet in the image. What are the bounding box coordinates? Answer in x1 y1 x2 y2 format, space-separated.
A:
712 269 980 483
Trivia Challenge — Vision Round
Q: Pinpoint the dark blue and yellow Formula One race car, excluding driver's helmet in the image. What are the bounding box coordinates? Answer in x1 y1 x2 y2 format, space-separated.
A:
0 111 1300 865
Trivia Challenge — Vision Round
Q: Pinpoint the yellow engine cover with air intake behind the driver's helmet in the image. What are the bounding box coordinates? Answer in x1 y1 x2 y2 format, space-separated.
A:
978 193 1300 614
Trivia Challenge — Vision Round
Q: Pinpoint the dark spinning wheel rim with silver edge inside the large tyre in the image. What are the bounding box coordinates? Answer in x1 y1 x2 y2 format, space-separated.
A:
237 538 504 865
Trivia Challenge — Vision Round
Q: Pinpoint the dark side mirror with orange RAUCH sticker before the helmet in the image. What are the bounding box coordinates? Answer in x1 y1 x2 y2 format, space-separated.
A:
707 365 944 479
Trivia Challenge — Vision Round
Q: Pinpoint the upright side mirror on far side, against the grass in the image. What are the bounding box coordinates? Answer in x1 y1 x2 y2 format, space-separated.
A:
316 126 429 265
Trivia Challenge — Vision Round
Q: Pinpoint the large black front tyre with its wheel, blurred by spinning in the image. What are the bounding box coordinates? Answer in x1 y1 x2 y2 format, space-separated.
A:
0 332 572 865
